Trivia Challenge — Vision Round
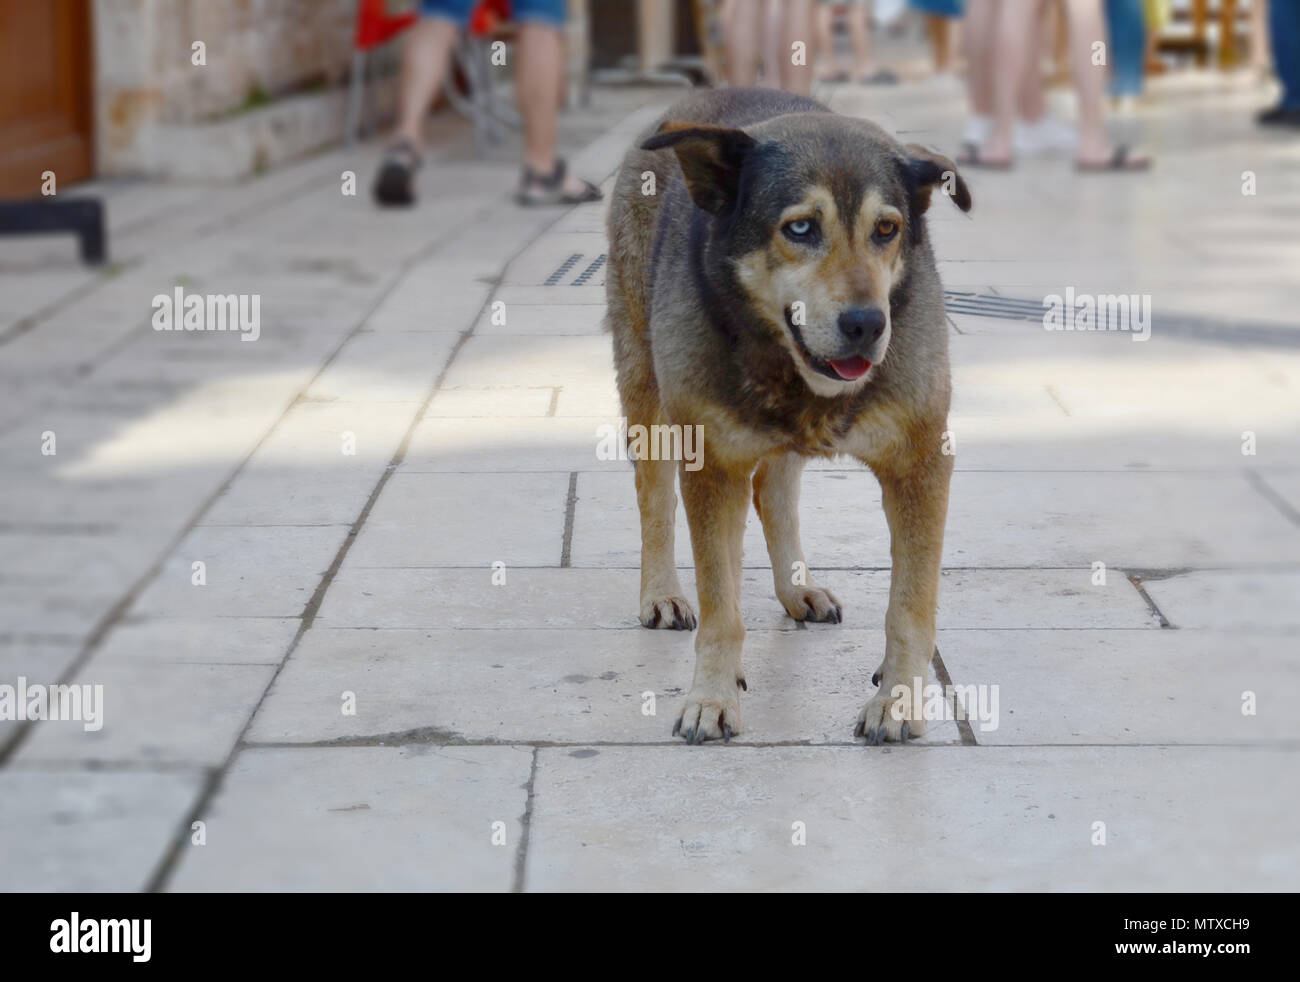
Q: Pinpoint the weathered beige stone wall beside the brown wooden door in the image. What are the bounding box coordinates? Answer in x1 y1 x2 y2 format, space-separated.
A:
92 0 400 178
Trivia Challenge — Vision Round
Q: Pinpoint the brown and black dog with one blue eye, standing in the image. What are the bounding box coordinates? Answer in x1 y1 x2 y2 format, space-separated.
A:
607 88 971 743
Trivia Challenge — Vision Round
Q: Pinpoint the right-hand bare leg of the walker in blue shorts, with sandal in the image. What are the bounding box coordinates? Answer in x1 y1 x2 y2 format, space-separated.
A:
514 0 594 198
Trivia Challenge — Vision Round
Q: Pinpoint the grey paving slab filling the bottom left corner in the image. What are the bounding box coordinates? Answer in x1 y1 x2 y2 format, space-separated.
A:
0 766 203 894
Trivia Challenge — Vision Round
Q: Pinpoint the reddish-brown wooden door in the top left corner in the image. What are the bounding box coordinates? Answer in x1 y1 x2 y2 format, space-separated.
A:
0 0 94 198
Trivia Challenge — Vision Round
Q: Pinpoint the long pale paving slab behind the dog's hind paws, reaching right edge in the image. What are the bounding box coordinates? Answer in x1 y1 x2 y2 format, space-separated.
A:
572 468 1300 568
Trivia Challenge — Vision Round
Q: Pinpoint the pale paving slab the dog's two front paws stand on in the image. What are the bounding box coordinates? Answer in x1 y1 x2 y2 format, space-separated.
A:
247 624 961 752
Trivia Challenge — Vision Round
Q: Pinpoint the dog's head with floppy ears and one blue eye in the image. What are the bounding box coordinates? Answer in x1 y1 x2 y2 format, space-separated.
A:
642 113 971 395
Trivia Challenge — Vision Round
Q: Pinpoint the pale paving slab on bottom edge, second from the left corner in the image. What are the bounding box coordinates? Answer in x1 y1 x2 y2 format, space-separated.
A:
169 744 533 892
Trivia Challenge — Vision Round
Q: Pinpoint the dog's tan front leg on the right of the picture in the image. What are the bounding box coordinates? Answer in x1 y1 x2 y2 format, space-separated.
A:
854 441 953 744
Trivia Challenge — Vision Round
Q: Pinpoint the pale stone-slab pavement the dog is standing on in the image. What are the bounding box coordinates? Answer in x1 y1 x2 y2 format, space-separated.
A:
0 79 1300 891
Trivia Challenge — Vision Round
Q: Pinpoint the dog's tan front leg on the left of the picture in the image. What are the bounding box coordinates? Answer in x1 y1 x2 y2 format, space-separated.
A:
672 454 753 744
